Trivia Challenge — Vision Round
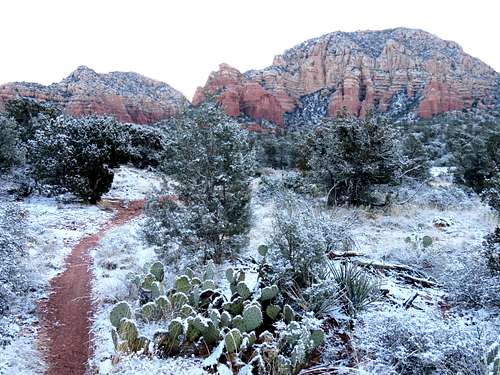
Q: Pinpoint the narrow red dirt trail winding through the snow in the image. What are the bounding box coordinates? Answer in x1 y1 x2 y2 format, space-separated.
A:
38 201 144 375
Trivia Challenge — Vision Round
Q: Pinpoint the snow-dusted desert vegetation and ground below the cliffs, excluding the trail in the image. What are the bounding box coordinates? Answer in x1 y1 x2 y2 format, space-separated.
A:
0 97 500 375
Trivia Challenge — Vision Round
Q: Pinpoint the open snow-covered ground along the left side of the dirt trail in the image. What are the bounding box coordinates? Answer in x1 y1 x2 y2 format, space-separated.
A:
0 197 112 375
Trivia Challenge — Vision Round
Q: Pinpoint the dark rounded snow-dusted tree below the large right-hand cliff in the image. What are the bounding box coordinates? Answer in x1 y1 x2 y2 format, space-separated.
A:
307 116 402 204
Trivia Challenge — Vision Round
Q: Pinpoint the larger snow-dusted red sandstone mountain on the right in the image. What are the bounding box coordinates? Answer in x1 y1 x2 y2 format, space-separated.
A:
193 28 498 125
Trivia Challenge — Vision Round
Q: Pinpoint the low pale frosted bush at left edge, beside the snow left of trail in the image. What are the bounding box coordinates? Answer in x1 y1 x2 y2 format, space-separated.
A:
0 204 28 315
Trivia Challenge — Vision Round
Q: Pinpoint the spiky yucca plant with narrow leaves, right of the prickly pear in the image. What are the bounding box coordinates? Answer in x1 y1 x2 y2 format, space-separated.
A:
327 261 379 316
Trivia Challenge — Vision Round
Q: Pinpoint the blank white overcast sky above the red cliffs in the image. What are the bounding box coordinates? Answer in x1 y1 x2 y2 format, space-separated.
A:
0 0 500 99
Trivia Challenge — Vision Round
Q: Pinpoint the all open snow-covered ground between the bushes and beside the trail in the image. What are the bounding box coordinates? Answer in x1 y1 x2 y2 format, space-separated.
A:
0 167 500 375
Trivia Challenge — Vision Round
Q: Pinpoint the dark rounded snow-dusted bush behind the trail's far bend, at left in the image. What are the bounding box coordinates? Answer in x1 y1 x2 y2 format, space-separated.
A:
29 116 119 203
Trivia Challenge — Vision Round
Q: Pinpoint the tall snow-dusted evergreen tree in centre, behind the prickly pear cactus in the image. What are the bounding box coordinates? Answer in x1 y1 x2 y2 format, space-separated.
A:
146 102 254 263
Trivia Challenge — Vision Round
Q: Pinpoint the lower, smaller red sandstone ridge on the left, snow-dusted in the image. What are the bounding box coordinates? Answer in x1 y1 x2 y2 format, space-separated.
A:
0 66 189 124
